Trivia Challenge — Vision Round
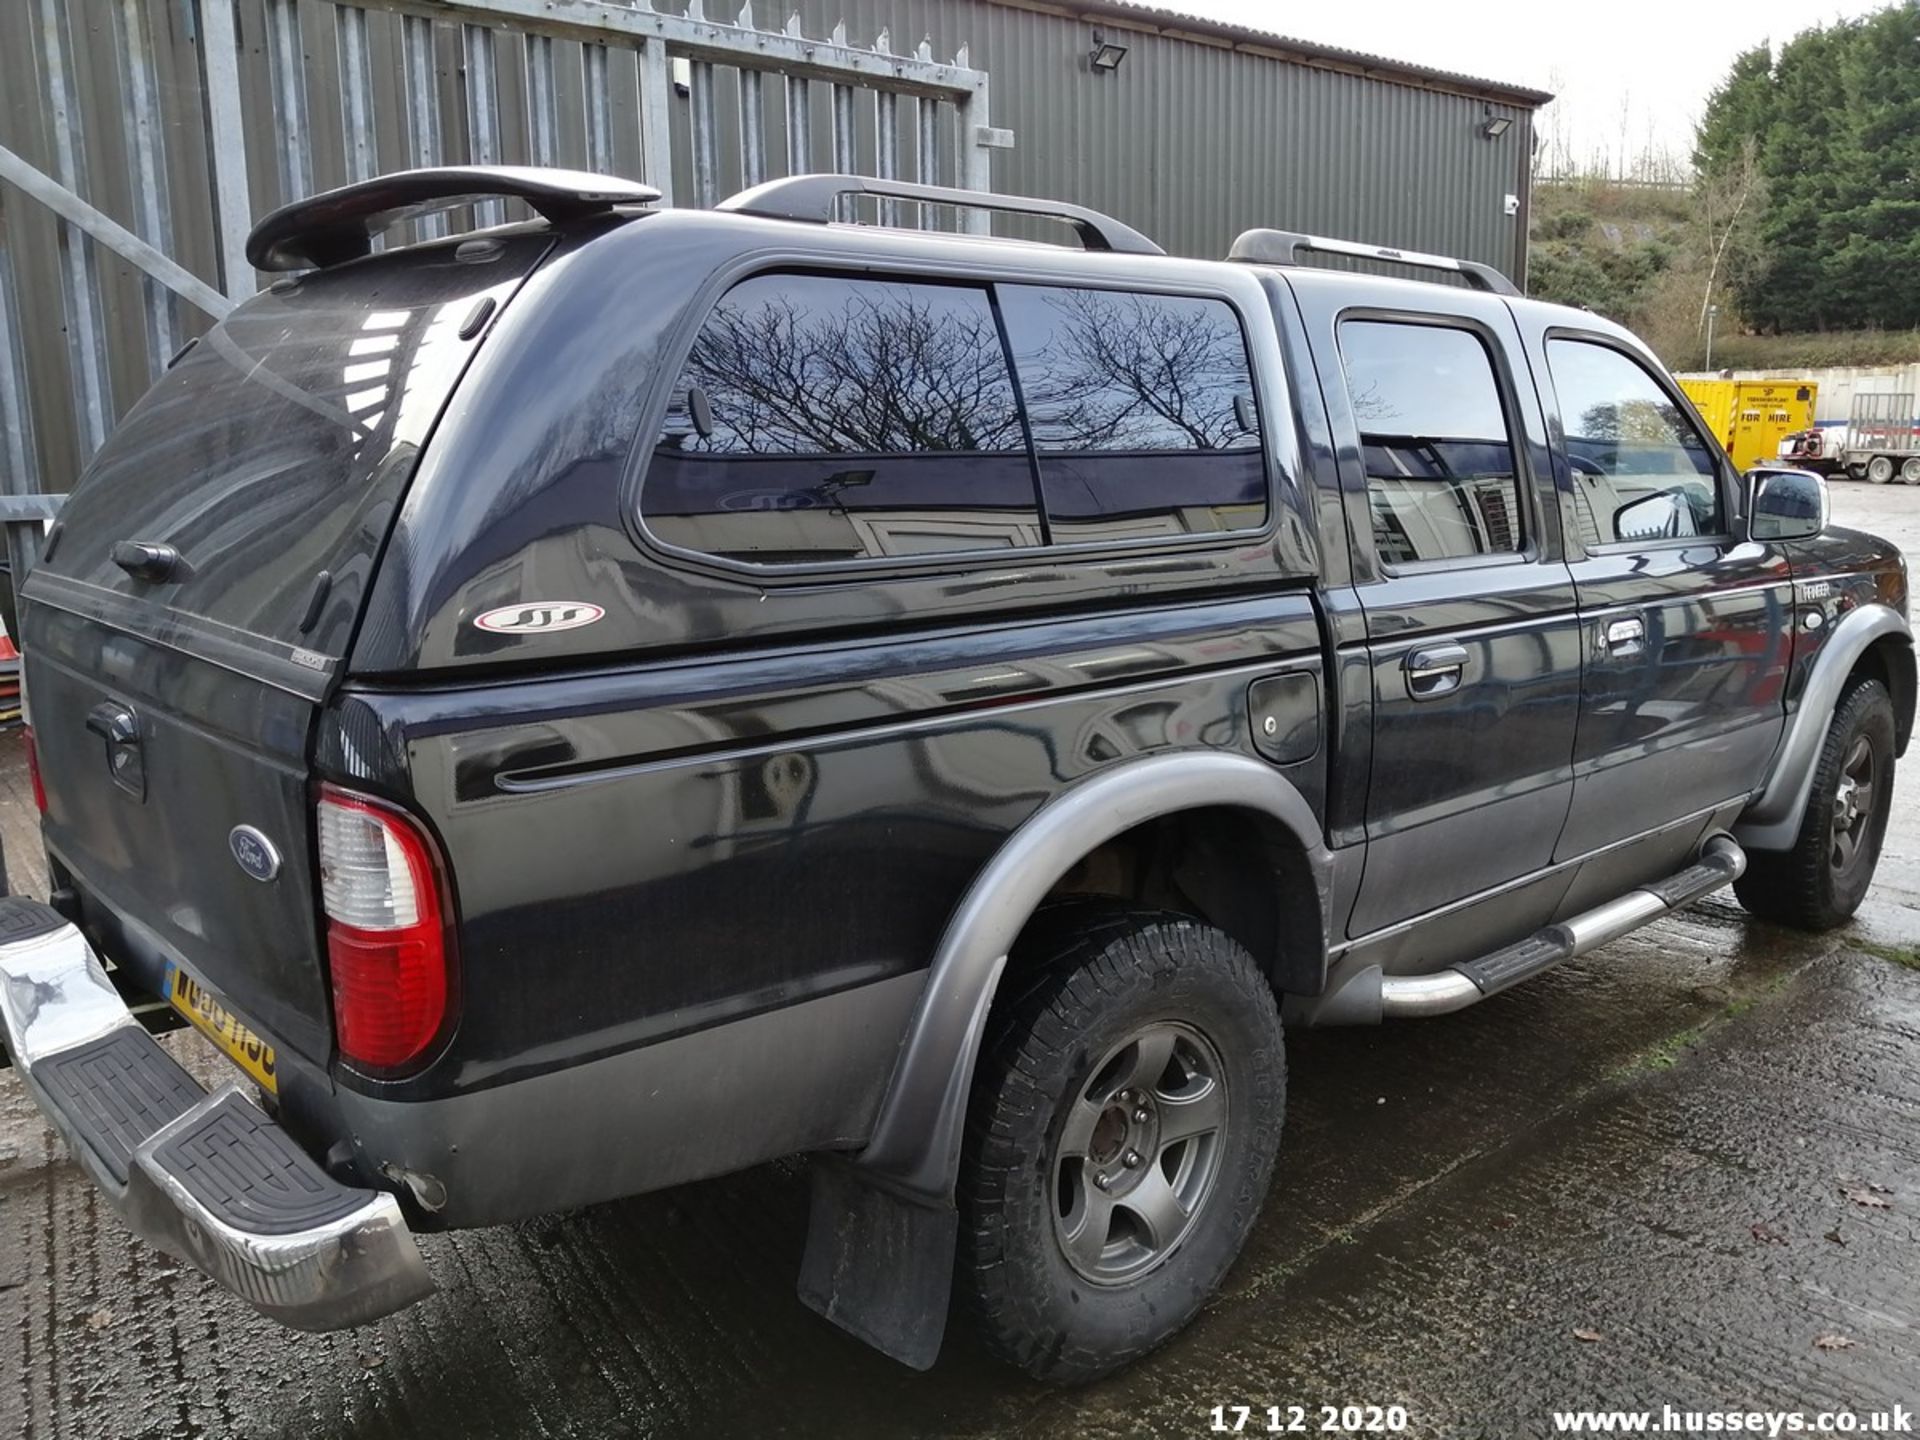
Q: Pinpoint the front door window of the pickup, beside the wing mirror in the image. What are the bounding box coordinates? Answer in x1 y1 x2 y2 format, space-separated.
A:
1548 340 1726 545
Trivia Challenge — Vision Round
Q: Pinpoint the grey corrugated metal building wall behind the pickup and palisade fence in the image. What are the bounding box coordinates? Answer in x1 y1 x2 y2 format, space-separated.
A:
0 0 1532 490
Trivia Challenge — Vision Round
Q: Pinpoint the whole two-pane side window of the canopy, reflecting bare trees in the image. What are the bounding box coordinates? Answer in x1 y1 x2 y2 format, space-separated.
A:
641 275 1267 564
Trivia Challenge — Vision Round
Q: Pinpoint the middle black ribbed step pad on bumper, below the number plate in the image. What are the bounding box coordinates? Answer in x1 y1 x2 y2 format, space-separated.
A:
34 1029 207 1185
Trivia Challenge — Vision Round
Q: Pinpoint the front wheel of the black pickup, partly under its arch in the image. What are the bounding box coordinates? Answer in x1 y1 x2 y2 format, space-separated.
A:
1734 680 1893 931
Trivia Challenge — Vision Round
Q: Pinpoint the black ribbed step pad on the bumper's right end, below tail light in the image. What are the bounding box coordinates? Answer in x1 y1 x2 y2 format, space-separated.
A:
154 1092 372 1235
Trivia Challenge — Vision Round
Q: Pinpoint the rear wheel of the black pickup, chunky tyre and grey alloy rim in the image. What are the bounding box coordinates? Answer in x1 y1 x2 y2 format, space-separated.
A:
954 902 1286 1382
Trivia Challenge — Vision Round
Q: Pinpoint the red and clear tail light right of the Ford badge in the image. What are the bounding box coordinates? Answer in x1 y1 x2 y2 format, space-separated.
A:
315 785 451 1071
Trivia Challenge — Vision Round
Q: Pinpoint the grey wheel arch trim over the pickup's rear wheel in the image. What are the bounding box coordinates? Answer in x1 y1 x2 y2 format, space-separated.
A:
854 751 1332 1206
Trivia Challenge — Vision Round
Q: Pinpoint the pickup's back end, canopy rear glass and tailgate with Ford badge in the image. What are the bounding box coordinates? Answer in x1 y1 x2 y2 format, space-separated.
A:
23 234 549 1058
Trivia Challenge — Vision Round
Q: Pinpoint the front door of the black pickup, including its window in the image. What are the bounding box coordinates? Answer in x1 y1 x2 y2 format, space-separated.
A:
1536 330 1793 858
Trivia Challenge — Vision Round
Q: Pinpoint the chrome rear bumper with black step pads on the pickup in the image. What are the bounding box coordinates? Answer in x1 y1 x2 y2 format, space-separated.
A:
0 897 434 1331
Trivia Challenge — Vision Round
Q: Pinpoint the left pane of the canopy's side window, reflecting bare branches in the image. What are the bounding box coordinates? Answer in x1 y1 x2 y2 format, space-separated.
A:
641 275 1041 564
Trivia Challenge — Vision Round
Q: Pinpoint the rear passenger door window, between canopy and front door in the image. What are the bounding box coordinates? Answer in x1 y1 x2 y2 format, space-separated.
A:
1340 321 1526 564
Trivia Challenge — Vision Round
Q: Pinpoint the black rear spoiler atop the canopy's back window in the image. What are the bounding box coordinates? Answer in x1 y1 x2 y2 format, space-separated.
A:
246 165 660 271
